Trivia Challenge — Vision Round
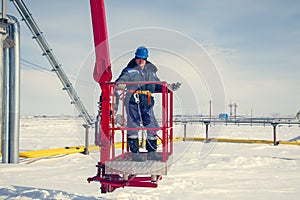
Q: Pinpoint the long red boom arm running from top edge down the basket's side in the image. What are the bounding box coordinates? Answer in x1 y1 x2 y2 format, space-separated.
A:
90 0 112 164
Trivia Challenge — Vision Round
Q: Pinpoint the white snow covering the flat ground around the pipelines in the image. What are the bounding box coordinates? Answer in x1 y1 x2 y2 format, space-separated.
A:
0 117 300 200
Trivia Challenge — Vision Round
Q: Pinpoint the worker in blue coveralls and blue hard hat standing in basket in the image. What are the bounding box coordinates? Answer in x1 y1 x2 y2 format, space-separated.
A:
116 46 181 162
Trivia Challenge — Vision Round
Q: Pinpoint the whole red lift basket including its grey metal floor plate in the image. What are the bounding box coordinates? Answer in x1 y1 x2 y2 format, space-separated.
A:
88 82 173 193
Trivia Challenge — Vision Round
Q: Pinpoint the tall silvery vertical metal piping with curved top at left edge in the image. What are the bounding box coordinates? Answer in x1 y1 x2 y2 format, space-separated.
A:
0 16 20 163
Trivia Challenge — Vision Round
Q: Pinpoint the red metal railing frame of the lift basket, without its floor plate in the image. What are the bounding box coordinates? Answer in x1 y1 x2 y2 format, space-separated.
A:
88 82 173 193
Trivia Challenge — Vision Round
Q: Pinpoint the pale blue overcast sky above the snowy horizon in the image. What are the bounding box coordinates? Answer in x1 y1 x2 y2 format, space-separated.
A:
7 0 300 116
